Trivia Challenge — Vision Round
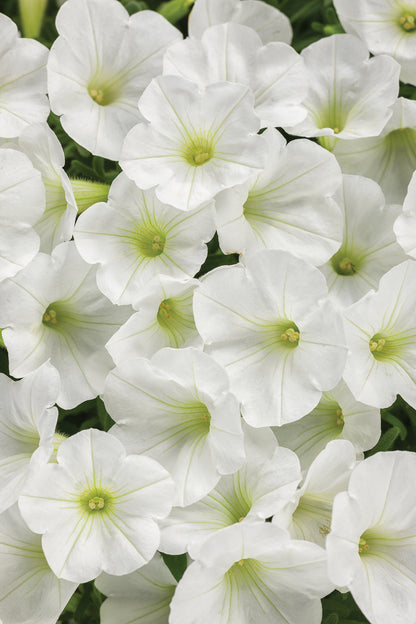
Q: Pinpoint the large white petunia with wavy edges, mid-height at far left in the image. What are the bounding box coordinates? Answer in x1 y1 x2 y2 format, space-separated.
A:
0 242 131 409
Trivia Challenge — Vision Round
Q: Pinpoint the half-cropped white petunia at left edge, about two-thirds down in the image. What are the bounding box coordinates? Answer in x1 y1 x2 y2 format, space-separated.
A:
0 363 60 516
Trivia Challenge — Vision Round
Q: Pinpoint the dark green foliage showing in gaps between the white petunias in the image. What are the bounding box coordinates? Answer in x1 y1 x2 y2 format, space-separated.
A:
0 0 416 624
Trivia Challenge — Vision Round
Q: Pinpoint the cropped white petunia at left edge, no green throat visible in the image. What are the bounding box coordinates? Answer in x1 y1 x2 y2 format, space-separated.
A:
0 149 45 282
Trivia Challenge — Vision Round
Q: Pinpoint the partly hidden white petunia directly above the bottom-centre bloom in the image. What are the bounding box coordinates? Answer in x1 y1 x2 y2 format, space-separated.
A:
160 447 301 559
